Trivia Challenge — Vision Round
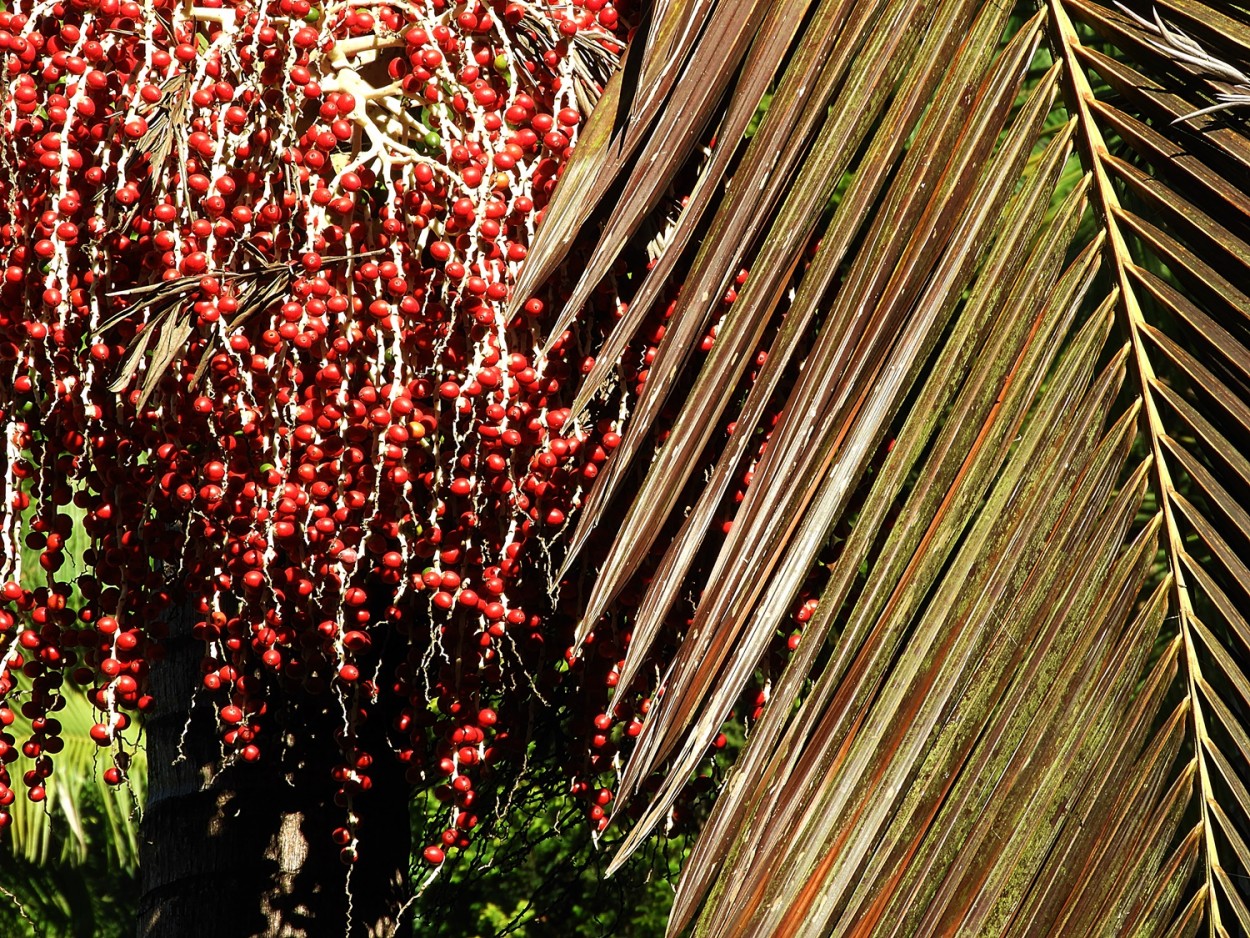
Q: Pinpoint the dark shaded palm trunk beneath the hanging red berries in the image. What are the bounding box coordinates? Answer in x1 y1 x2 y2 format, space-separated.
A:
139 605 411 938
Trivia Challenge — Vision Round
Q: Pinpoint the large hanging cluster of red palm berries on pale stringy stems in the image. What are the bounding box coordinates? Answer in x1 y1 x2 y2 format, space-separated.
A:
0 0 626 857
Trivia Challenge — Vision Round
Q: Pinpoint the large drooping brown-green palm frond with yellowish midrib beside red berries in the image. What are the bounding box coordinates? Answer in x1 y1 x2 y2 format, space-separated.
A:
529 0 1250 937
